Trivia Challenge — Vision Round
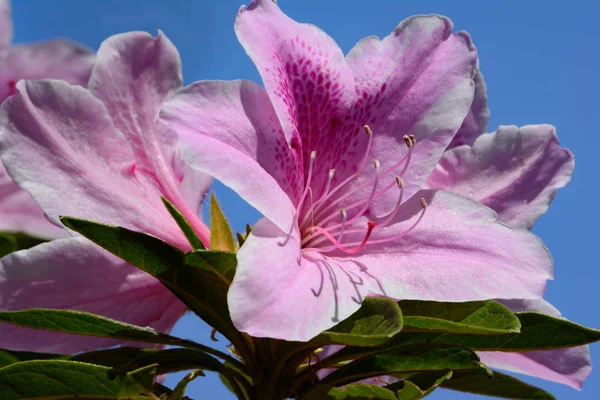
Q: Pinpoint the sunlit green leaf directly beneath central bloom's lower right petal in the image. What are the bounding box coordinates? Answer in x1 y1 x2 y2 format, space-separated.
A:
399 300 521 335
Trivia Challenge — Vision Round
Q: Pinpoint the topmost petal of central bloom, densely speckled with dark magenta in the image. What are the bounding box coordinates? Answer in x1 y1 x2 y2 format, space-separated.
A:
235 0 356 195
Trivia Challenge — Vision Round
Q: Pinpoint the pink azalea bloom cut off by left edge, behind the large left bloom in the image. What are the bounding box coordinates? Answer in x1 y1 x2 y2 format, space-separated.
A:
0 0 94 239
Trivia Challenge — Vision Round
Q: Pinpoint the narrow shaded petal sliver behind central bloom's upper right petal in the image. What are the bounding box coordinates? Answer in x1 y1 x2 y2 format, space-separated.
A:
449 68 490 148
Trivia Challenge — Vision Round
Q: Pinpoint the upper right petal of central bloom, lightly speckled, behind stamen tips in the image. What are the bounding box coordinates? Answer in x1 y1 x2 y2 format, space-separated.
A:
347 15 477 201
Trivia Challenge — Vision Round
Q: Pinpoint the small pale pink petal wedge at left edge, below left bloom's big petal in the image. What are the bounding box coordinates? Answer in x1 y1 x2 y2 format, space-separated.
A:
0 164 68 239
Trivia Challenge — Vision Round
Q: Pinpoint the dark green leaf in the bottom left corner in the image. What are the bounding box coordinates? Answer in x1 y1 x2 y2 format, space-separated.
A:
0 360 156 400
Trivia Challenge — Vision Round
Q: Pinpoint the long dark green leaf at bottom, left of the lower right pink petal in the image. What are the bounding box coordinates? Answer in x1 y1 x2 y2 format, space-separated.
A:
322 344 487 386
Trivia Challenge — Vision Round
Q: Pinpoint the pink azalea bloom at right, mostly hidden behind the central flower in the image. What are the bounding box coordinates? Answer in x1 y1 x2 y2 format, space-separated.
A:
427 74 592 389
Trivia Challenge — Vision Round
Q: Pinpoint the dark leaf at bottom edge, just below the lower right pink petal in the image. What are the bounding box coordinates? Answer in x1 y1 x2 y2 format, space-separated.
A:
442 371 555 400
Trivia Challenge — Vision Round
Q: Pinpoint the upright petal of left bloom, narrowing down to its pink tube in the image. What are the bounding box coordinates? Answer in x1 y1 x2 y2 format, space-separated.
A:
89 32 209 243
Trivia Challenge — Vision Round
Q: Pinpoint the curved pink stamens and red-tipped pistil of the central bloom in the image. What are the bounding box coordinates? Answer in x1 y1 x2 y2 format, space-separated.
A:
298 125 427 254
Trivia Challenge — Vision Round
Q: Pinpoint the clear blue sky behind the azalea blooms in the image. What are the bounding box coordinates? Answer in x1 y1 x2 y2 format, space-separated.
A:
13 0 600 400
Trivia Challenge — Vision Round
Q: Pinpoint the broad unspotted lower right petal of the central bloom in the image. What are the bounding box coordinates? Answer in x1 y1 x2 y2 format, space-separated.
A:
348 191 552 301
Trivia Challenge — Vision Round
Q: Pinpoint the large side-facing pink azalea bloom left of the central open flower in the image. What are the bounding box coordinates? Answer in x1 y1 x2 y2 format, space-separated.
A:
0 32 211 353
